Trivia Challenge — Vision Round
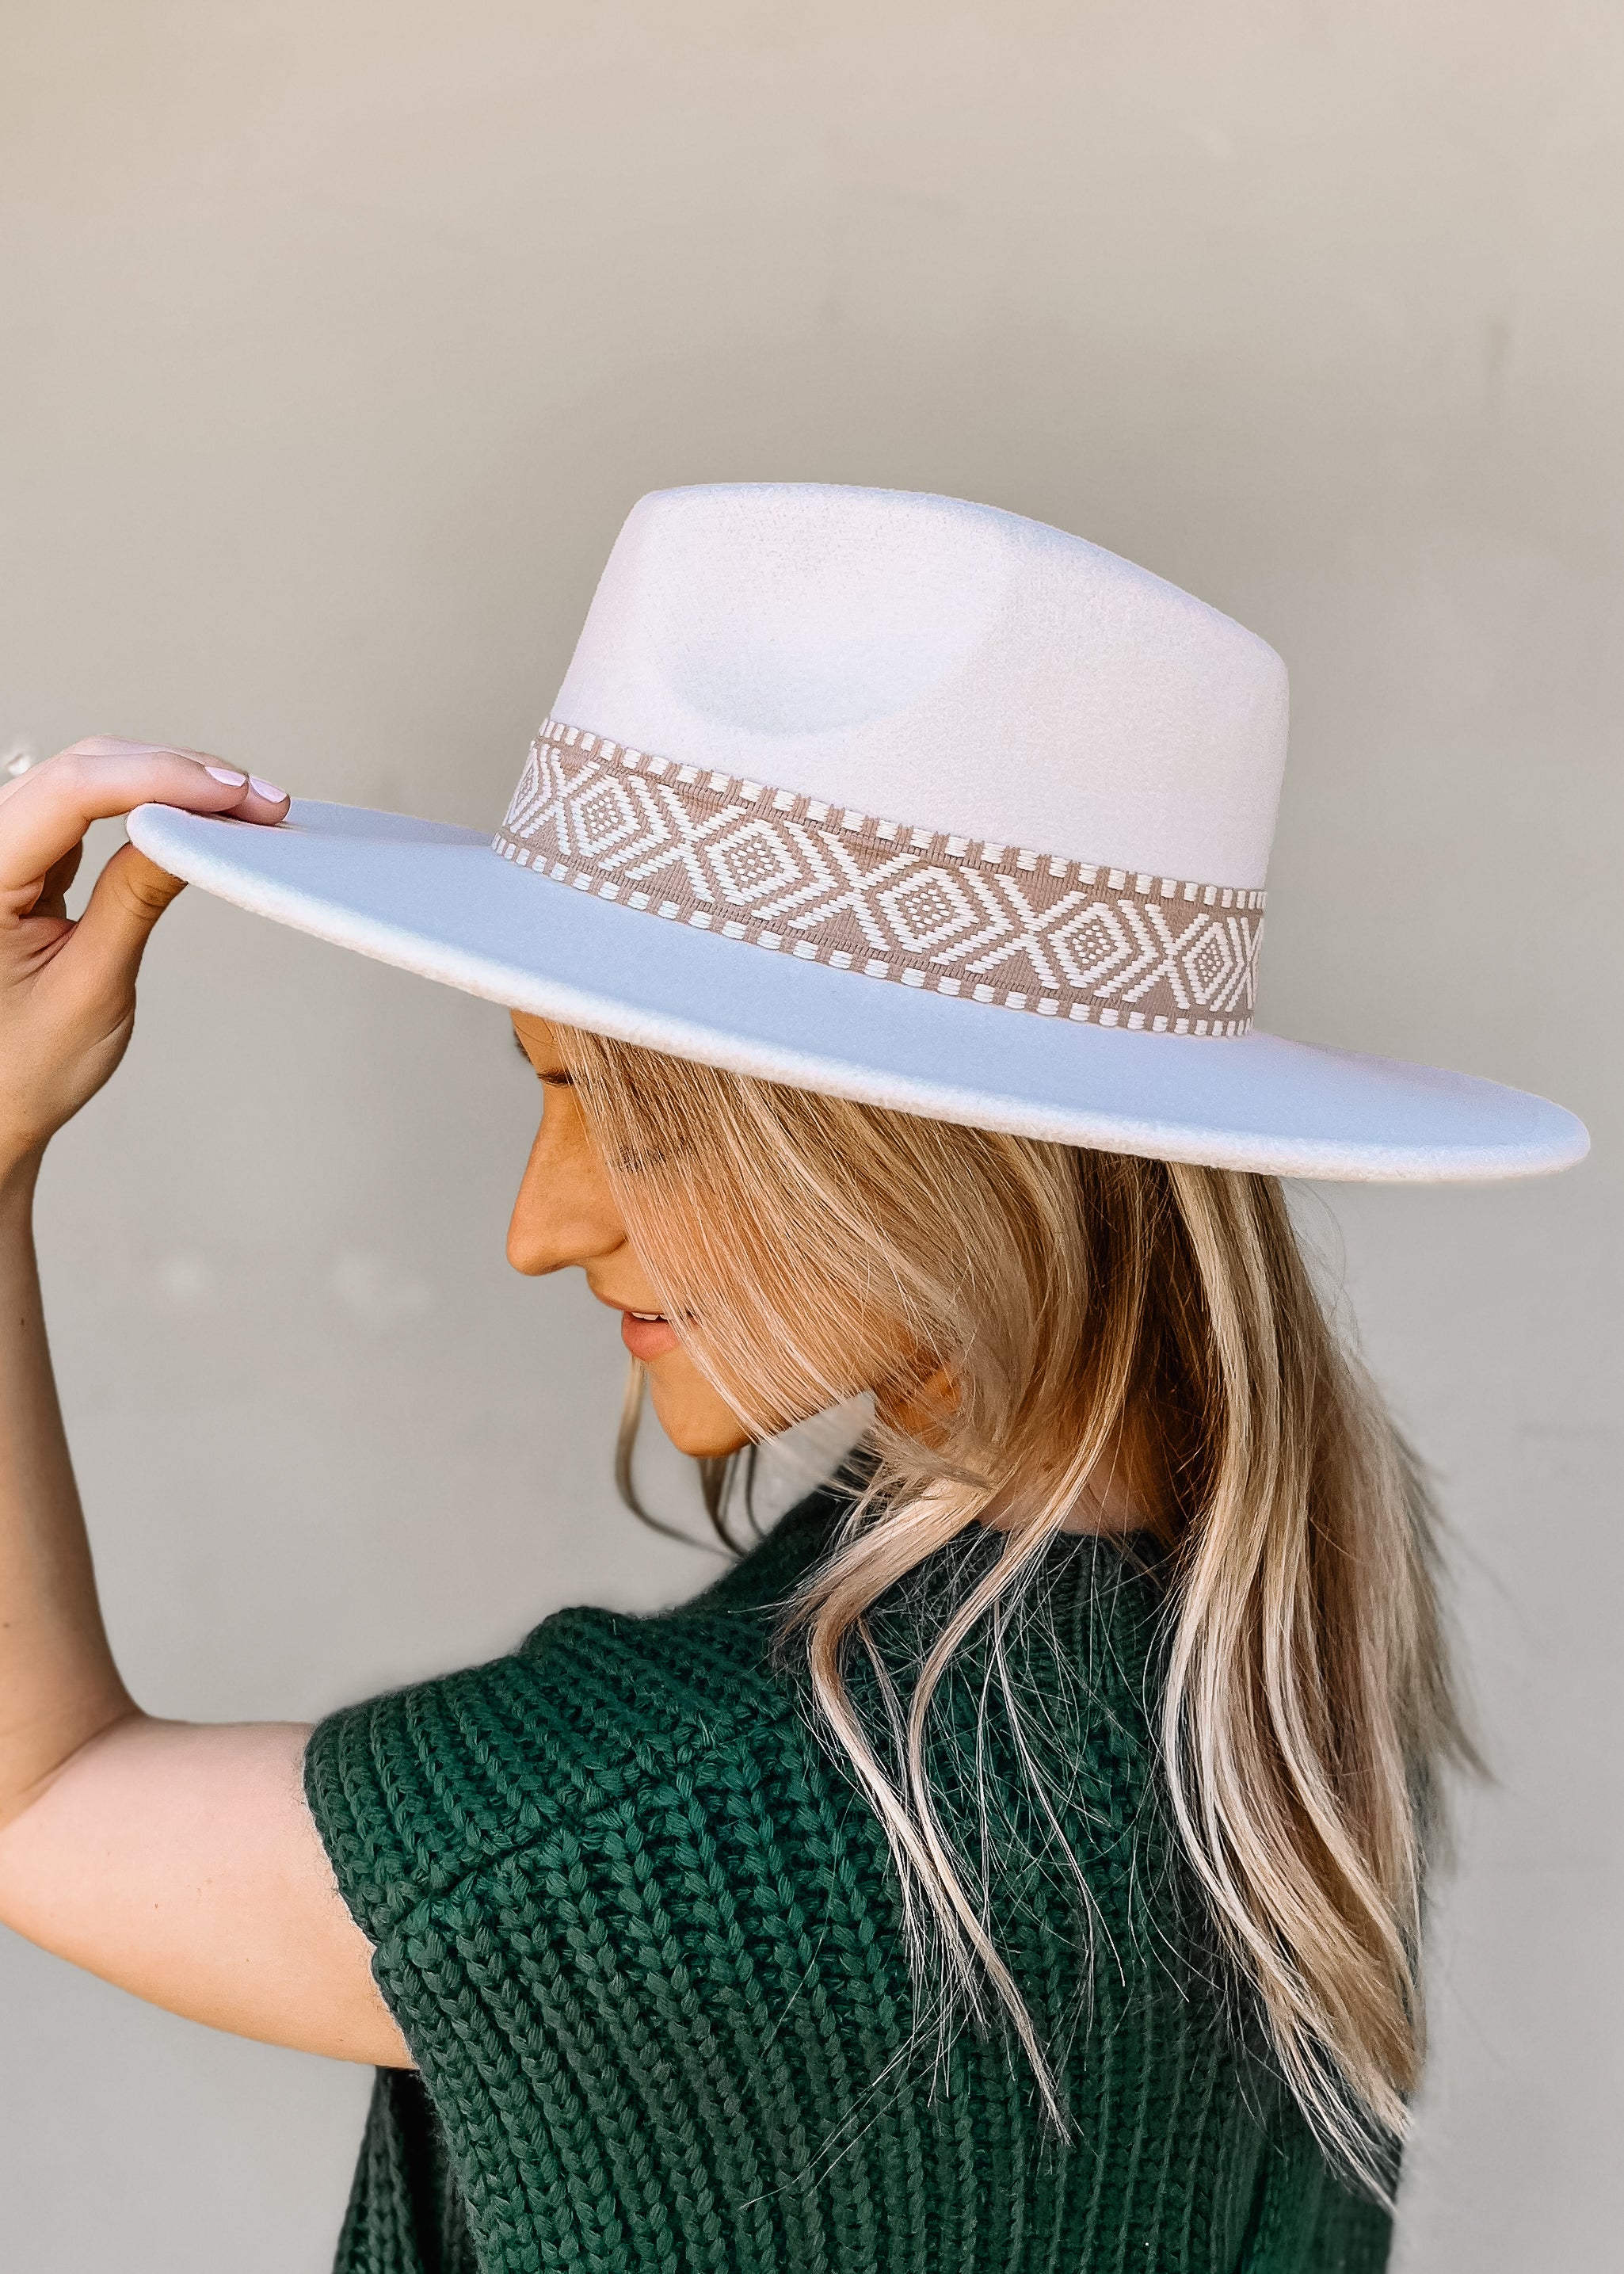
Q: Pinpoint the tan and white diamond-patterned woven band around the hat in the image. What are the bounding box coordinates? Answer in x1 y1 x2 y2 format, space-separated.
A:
491 719 1264 1035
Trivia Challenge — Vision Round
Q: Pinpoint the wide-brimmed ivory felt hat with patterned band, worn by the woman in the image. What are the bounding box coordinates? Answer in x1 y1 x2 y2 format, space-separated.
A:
130 484 1588 1181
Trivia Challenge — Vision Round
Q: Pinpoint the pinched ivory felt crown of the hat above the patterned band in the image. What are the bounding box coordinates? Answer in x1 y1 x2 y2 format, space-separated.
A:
553 482 1287 887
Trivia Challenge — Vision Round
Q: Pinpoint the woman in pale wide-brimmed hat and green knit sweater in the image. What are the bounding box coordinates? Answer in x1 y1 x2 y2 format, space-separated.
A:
0 486 1585 2274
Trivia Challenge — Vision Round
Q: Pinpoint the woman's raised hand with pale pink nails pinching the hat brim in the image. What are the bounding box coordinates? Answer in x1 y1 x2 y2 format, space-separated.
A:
0 734 289 1176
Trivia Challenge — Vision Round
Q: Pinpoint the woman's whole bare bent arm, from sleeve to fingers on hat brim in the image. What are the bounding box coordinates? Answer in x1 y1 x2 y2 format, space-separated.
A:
0 743 410 2067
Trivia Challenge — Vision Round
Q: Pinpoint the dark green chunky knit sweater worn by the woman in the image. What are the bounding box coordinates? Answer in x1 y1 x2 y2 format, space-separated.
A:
307 1490 1387 2274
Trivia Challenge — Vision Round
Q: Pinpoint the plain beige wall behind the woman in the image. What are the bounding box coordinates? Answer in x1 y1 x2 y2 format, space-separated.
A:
0 0 1624 2274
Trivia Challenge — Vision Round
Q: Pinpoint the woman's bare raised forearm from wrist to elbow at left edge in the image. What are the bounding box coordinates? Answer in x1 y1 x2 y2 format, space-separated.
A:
0 1160 134 1826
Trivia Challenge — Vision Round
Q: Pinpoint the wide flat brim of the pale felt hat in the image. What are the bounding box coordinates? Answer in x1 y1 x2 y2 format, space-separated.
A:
130 800 1590 1182
